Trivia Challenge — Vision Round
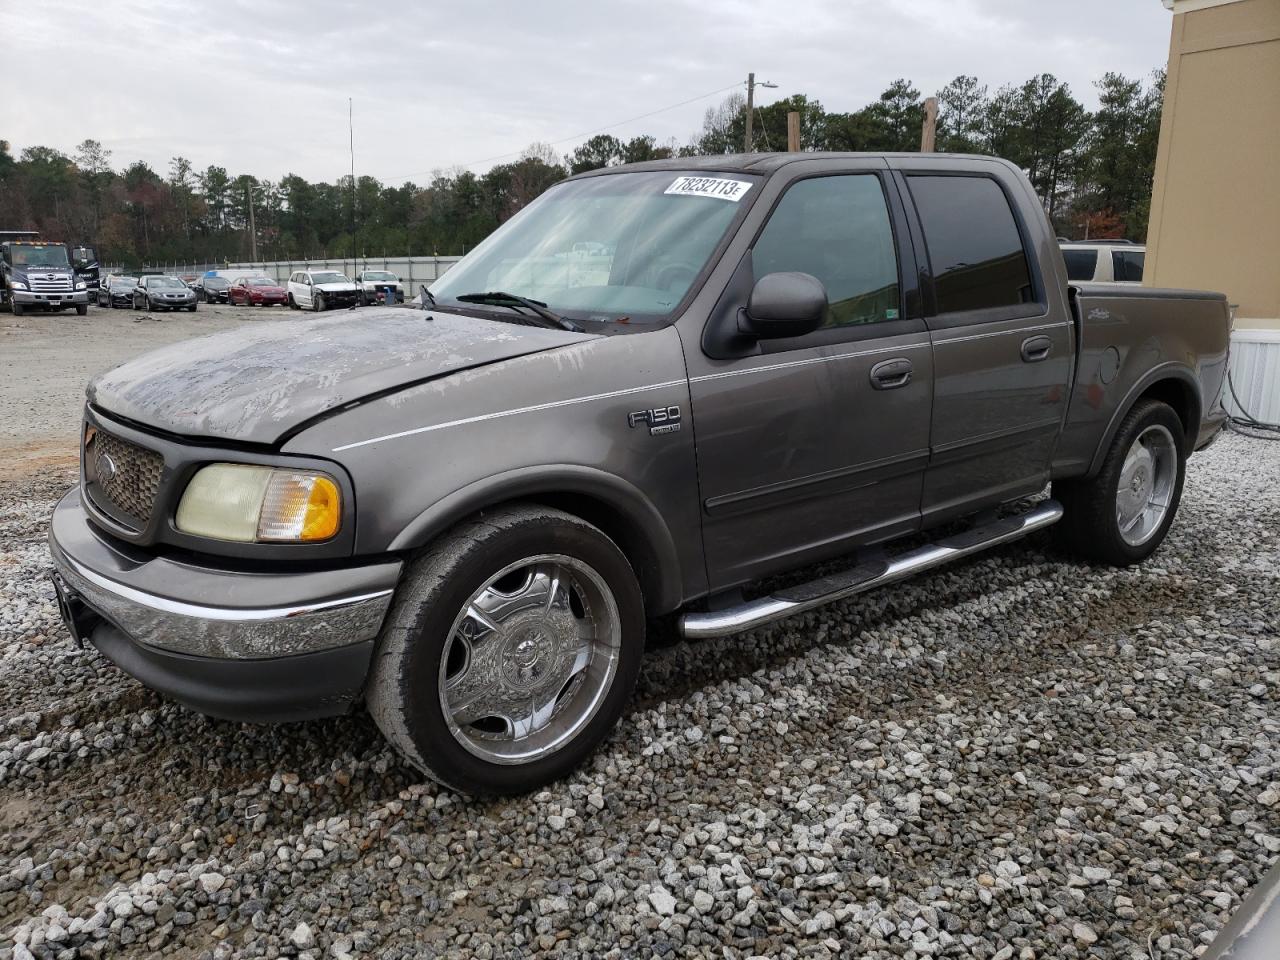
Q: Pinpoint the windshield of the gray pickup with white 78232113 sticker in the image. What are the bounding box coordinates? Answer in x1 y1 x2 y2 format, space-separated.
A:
431 172 756 323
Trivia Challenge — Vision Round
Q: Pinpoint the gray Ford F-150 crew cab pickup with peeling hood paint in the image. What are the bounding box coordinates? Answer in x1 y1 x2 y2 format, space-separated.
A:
50 154 1230 792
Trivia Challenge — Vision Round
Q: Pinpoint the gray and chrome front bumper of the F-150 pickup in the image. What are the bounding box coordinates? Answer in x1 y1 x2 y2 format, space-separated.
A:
49 490 401 721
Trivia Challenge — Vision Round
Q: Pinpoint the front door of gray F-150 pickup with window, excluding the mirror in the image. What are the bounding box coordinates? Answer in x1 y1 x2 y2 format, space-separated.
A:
686 171 933 590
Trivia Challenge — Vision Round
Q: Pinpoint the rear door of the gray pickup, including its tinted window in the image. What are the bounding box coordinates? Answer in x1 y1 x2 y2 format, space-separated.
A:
900 161 1074 525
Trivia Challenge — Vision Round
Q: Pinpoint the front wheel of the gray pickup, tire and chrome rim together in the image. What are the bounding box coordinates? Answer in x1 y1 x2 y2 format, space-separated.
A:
366 506 644 794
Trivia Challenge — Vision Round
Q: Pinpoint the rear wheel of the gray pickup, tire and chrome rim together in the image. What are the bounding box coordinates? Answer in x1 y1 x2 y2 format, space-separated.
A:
1053 401 1187 566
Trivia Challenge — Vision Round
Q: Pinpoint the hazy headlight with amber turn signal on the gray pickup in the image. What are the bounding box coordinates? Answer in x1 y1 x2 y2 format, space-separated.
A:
177 463 342 543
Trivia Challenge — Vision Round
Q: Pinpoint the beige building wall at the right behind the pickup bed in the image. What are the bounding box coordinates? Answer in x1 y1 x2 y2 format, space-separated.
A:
1146 0 1280 330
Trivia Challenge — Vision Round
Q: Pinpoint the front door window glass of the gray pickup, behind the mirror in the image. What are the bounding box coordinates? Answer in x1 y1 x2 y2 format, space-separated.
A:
751 174 899 328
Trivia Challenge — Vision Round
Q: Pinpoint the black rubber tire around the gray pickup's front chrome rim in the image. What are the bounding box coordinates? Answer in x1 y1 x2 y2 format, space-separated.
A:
366 504 645 795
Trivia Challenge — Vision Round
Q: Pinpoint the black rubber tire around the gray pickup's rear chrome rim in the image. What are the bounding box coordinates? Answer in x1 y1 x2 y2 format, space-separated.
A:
1053 399 1187 567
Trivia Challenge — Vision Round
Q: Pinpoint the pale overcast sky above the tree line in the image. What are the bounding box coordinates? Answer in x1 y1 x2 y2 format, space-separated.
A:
0 0 1171 183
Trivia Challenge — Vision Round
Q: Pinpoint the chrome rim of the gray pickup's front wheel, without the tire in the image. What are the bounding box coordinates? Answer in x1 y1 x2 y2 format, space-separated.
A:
438 554 622 764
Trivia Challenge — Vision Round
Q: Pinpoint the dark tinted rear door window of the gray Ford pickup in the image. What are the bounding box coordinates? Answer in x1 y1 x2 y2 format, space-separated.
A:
909 177 1034 316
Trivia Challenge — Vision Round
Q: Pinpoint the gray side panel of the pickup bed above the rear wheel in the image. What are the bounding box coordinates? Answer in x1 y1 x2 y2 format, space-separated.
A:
1052 283 1231 477
